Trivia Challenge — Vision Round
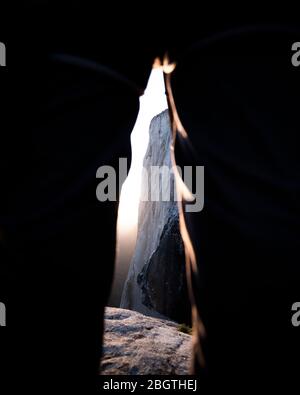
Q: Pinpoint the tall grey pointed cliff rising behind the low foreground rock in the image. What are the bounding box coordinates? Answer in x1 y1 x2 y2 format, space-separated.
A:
121 110 190 323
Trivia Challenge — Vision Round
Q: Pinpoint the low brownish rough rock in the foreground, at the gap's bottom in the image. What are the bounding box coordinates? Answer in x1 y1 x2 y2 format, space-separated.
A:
101 307 192 375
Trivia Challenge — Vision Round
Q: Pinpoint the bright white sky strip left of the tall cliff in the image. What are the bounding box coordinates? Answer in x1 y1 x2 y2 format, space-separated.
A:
109 67 168 306
